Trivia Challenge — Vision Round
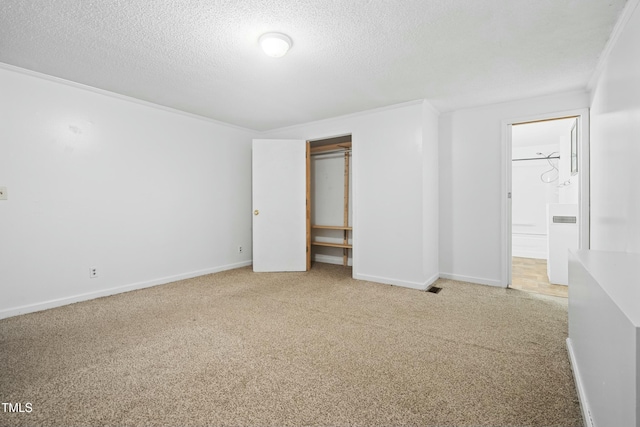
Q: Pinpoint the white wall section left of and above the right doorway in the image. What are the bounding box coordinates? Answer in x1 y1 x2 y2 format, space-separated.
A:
439 92 588 286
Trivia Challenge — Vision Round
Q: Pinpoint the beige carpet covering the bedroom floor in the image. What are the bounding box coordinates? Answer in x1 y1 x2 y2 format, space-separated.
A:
0 263 581 426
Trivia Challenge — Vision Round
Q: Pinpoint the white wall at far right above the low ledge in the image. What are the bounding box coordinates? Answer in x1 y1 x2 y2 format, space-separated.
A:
591 1 640 253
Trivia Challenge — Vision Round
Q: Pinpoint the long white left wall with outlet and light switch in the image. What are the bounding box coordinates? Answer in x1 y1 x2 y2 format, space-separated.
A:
0 64 255 317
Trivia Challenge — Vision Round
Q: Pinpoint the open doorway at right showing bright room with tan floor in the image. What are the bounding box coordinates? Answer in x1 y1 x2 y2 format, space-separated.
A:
506 112 588 297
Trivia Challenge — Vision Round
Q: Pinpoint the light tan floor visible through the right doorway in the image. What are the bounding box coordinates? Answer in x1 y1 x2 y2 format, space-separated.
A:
510 257 569 298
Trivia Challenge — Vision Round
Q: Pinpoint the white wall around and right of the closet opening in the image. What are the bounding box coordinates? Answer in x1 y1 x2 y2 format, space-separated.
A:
263 102 438 288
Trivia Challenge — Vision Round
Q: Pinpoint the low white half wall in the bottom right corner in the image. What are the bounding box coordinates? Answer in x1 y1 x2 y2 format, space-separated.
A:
567 251 640 427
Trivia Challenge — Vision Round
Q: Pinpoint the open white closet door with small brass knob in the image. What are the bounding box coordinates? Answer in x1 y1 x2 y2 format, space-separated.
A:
252 139 307 272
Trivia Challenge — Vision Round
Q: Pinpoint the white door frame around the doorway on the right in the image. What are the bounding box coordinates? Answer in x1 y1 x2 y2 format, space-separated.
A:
500 108 591 287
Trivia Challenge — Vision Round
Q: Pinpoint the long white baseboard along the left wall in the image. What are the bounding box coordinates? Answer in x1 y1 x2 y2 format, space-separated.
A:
0 260 253 319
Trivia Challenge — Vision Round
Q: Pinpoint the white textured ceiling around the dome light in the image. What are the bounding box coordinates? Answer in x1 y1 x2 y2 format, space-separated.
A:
0 0 625 130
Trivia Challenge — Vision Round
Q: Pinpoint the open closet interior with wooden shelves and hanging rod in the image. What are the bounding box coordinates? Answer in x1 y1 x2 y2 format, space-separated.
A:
307 135 353 267
